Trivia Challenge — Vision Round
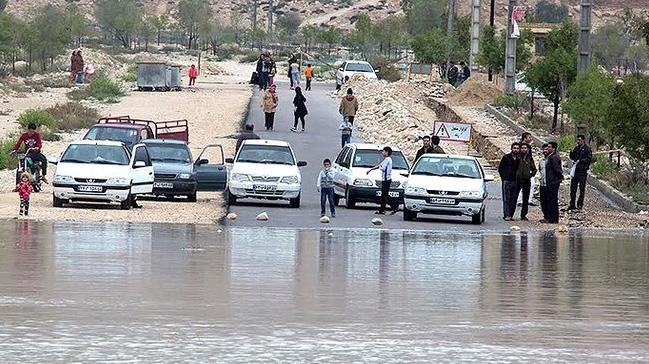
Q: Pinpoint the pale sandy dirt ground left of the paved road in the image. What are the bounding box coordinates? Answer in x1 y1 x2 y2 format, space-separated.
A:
0 59 253 224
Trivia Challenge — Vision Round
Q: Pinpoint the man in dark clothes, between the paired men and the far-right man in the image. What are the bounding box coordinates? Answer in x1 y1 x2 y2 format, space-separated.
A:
539 142 563 224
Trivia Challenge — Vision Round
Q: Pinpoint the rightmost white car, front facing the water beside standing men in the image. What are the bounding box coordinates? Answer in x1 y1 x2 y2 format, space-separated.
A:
403 154 494 224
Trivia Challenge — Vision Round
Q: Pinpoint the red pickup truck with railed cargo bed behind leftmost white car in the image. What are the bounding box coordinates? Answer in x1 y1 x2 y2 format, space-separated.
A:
83 116 189 148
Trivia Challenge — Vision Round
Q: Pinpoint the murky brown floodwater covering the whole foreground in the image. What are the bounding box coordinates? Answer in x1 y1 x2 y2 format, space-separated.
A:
0 221 649 363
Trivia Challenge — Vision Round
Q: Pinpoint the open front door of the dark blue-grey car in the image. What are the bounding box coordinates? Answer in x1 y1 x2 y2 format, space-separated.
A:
194 144 228 191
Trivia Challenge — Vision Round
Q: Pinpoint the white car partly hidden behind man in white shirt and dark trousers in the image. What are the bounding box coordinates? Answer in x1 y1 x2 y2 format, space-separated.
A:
332 143 409 209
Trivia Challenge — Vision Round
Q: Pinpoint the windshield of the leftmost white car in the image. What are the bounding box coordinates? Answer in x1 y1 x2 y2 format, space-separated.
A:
61 144 130 166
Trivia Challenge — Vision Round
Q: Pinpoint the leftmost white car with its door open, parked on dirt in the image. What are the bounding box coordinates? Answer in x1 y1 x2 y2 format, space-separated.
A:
52 140 154 210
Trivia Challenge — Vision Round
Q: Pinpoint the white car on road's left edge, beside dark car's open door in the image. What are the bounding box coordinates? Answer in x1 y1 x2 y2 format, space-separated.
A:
227 139 306 208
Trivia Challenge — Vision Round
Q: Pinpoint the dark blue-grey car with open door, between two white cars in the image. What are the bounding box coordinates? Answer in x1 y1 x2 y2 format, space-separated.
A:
143 139 227 202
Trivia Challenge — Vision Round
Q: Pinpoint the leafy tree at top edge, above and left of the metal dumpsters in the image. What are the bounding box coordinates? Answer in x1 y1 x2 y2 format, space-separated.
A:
97 0 141 48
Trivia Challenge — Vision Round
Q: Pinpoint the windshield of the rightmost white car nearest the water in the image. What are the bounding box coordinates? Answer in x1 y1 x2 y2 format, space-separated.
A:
411 156 482 179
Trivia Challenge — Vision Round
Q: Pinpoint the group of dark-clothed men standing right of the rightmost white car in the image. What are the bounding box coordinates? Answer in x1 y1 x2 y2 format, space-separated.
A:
498 133 592 224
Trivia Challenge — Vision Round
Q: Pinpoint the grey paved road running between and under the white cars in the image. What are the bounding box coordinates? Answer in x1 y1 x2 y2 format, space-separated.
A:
229 83 508 231
